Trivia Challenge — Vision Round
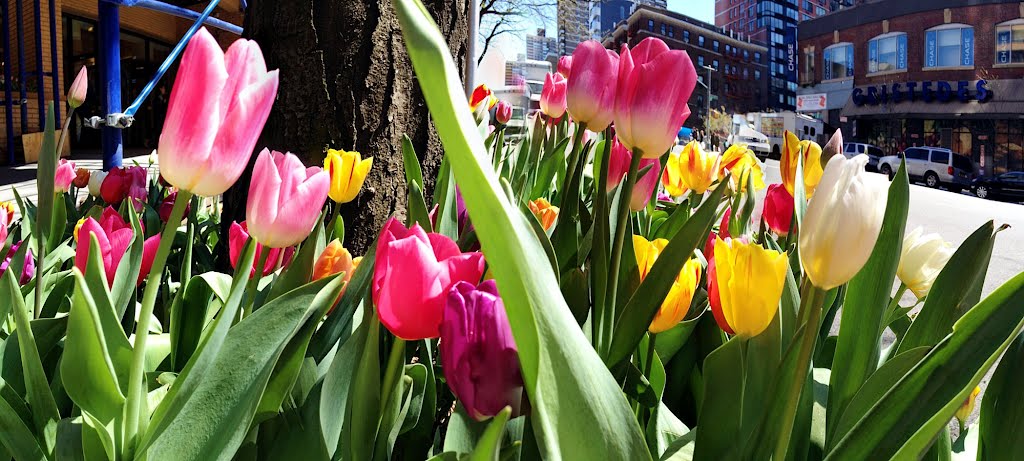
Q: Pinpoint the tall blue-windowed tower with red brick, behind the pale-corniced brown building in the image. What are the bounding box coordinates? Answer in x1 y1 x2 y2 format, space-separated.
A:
715 0 831 111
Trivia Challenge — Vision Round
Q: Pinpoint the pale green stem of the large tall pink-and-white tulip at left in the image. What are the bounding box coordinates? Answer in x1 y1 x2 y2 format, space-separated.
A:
124 191 193 452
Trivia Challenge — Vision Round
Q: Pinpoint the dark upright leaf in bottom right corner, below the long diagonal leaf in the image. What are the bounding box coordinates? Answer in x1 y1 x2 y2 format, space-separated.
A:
974 334 1024 459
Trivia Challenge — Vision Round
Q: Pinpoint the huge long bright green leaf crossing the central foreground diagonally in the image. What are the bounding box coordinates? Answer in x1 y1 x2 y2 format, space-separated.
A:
394 0 650 460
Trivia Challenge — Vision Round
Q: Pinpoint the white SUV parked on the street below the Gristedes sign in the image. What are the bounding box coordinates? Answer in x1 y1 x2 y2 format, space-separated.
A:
879 148 978 193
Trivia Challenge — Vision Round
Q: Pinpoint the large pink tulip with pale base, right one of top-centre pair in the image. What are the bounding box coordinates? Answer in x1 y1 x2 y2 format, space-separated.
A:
614 38 697 158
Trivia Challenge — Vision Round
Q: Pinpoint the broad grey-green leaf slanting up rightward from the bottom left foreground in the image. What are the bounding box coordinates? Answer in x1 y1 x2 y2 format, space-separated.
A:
148 270 343 460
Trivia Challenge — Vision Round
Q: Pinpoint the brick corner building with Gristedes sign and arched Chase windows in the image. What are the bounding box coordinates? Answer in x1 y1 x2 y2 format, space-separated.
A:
799 0 1024 174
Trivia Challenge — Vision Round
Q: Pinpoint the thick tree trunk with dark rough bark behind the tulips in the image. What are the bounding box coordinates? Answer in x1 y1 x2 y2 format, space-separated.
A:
223 0 469 255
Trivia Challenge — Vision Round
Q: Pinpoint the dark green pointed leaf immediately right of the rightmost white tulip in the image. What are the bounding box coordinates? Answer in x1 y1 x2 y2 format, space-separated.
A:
896 221 1002 353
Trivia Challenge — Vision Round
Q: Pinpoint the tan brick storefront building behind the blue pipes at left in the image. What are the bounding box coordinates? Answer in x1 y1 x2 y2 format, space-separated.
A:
0 0 243 164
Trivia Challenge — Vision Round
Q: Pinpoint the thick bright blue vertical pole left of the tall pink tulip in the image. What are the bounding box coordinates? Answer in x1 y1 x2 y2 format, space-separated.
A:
97 0 124 171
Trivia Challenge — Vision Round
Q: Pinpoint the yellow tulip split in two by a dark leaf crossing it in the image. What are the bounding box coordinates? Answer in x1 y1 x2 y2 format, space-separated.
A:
633 236 701 334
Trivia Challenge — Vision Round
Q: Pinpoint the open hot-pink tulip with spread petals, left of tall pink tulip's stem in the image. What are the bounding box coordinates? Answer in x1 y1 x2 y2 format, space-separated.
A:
75 207 160 286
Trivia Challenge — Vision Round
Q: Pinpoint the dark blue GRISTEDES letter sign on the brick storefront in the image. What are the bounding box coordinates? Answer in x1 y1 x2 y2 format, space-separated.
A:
850 80 992 106
